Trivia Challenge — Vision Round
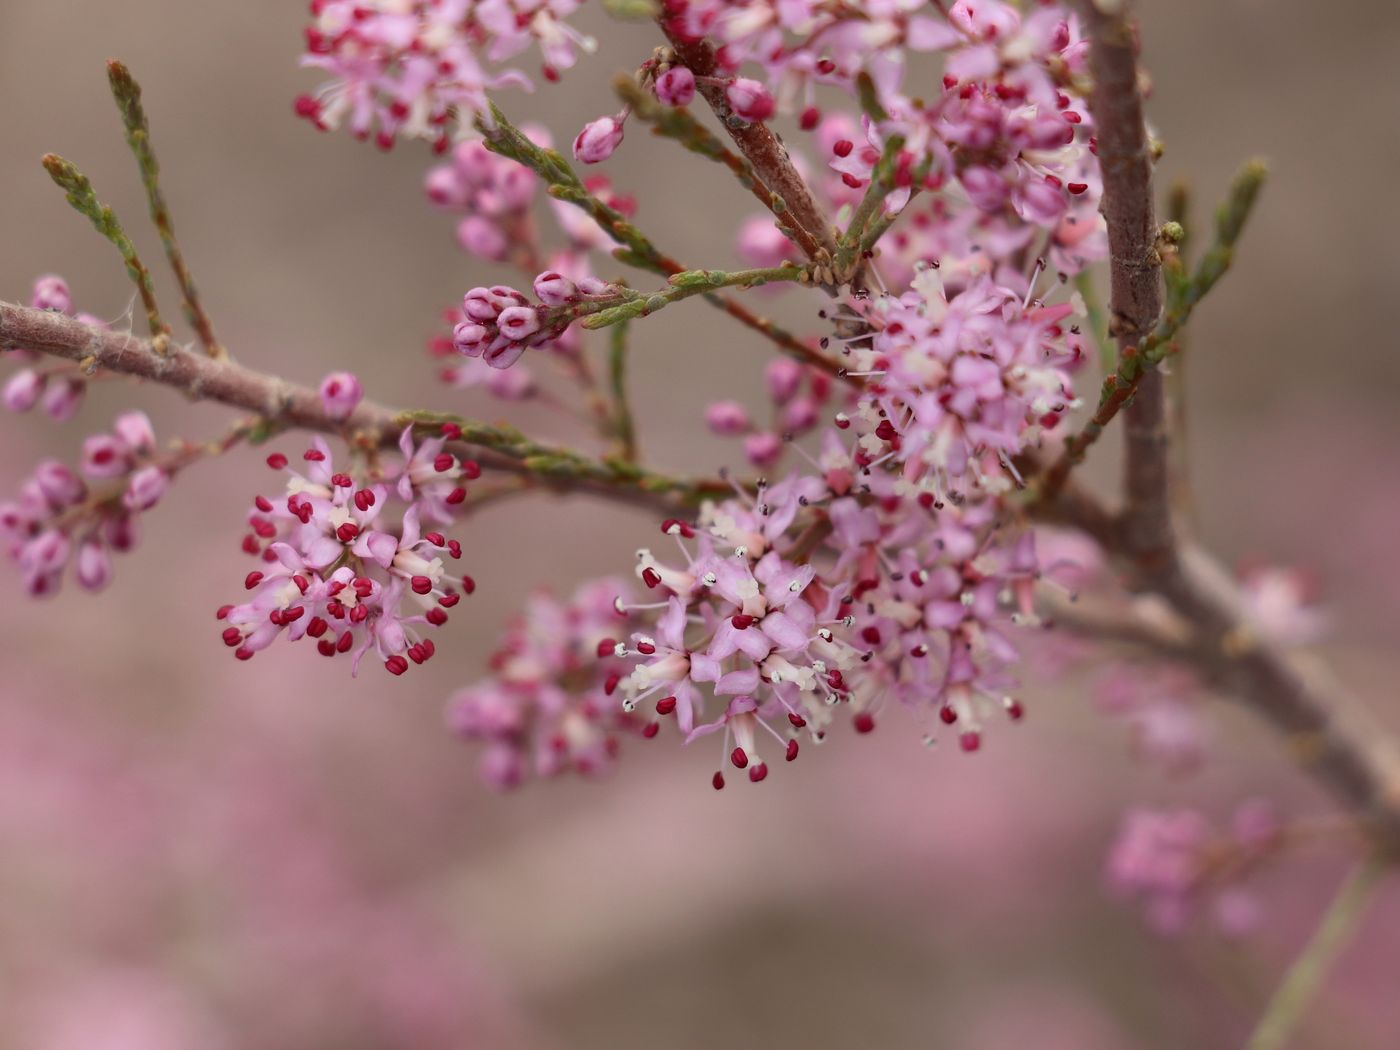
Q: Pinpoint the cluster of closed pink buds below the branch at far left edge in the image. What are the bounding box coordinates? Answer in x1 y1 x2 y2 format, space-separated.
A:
0 412 168 596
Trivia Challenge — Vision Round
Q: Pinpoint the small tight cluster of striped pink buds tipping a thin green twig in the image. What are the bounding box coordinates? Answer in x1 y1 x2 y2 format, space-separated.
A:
452 270 617 368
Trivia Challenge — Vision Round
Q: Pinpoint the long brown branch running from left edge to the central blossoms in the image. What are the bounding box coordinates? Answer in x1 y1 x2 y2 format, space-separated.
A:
0 302 732 514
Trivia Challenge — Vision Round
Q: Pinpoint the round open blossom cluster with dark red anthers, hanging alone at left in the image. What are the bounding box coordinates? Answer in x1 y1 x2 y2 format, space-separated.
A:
218 424 480 675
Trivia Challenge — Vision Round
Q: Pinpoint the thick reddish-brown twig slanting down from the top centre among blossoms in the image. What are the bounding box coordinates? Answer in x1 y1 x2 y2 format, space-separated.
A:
661 26 836 260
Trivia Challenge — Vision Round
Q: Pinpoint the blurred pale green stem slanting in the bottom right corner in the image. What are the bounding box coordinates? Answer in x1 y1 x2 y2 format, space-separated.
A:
1246 854 1389 1050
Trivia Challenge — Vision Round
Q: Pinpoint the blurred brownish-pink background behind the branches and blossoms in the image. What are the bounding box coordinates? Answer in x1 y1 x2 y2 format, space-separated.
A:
0 0 1400 1050
